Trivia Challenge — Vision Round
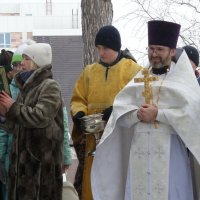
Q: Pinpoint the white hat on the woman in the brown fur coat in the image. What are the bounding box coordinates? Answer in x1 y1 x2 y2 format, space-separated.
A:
23 43 52 67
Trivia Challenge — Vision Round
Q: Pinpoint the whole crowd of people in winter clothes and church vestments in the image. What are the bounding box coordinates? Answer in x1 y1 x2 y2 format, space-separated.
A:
0 20 200 200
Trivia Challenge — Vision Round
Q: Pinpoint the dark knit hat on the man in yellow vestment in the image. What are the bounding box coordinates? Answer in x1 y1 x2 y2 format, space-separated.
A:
95 25 121 51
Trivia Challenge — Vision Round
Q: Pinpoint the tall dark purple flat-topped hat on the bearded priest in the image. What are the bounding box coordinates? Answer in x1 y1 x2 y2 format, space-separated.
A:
148 20 181 48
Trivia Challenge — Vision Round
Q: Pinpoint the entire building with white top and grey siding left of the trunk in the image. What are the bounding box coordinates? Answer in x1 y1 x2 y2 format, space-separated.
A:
0 0 83 181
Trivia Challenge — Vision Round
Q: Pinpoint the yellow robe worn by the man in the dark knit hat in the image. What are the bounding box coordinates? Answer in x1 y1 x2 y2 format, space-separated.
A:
71 58 141 200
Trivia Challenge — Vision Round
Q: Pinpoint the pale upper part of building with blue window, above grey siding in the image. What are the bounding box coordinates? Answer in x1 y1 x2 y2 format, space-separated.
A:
0 0 81 49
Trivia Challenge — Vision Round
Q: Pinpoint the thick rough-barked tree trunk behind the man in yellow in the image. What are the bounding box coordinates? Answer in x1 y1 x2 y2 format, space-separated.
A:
81 0 113 65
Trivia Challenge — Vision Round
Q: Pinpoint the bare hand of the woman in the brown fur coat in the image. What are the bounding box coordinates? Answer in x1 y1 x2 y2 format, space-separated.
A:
0 91 15 116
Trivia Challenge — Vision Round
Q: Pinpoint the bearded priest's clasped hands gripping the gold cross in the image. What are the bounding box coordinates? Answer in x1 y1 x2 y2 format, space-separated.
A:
137 104 158 122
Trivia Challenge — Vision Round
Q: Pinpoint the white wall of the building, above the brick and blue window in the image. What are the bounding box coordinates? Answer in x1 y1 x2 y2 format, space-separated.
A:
0 0 81 32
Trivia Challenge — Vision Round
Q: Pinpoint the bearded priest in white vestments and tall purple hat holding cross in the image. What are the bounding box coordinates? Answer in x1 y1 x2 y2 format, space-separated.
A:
91 20 200 200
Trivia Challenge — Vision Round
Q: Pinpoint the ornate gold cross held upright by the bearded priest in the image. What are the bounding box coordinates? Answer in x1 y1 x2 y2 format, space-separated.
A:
134 68 159 104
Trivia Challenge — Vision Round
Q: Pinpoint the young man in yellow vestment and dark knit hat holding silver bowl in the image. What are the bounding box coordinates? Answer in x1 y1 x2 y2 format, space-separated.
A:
71 25 141 200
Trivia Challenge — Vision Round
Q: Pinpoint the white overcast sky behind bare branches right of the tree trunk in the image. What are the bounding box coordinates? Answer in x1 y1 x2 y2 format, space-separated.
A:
112 0 200 64
